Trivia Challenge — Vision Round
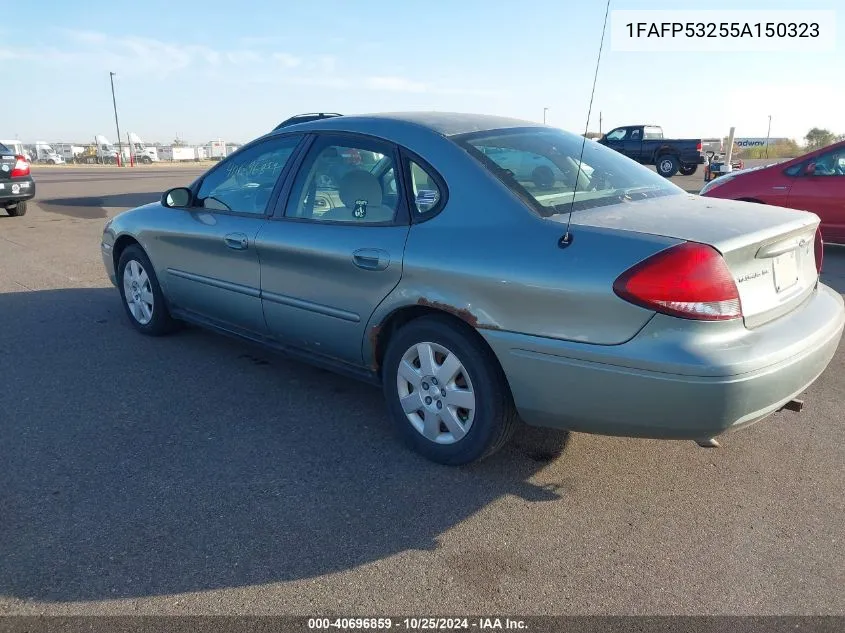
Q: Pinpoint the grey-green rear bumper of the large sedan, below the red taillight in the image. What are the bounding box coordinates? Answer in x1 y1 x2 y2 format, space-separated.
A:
482 284 845 439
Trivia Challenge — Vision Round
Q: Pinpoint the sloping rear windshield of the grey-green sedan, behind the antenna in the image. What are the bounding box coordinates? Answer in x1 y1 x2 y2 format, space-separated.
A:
455 127 684 217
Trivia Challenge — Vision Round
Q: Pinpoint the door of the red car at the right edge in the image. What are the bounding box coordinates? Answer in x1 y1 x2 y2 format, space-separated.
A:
788 145 845 243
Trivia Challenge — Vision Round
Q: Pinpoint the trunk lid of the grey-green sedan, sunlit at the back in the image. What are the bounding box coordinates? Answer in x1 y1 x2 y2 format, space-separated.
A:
555 194 819 328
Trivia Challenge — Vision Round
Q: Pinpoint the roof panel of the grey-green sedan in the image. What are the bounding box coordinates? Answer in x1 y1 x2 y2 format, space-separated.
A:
274 112 544 137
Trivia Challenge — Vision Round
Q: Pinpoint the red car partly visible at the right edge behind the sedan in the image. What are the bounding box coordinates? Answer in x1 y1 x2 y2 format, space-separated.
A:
701 141 845 244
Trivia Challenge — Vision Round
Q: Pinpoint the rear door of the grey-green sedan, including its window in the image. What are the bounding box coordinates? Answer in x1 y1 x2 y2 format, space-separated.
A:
257 134 409 365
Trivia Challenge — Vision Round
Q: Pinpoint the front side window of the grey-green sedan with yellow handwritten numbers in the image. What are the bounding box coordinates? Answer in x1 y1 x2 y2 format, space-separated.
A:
196 135 302 215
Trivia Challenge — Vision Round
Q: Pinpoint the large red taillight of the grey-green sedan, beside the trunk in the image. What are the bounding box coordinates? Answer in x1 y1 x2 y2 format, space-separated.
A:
613 242 742 321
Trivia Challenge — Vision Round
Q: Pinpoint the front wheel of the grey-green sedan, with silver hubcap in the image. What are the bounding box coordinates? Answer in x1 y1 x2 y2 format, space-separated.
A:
117 244 177 336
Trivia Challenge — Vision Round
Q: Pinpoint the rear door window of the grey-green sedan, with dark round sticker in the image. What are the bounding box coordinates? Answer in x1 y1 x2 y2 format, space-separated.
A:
285 138 399 224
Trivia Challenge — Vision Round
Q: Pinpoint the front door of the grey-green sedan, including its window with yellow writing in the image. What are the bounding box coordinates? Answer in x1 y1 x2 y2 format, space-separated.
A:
155 135 302 334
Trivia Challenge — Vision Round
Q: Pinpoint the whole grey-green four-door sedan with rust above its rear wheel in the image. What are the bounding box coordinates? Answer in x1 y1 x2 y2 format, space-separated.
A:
101 113 845 464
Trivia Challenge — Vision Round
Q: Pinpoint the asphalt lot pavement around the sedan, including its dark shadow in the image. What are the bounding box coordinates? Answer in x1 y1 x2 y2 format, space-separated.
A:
0 167 845 616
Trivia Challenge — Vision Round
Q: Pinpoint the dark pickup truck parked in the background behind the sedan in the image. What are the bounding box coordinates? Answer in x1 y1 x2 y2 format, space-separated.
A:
598 125 707 178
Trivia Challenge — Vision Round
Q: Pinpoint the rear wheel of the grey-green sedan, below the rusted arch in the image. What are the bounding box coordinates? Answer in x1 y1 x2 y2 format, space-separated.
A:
382 315 519 466
